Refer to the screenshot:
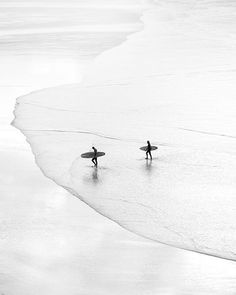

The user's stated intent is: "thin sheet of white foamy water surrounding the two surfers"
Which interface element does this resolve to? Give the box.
[14,1,236,259]
